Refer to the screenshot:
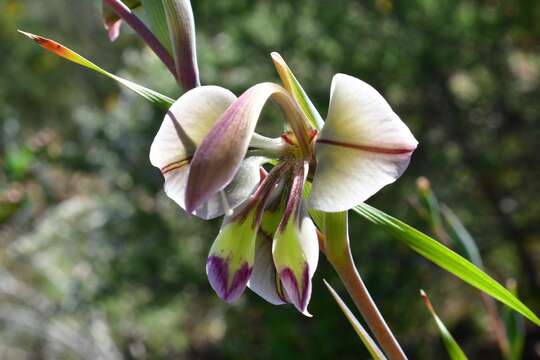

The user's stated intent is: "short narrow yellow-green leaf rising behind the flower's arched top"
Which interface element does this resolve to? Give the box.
[271,52,324,130]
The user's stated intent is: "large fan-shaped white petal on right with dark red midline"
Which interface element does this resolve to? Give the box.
[309,74,418,212]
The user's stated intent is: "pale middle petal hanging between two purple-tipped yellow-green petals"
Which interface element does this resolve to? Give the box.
[248,233,285,305]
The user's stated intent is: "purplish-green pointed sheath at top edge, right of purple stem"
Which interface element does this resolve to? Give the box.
[165,0,200,90]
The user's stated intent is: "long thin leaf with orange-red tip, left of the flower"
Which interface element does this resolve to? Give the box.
[18,30,174,109]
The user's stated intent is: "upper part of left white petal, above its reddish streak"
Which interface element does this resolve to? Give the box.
[150,86,236,169]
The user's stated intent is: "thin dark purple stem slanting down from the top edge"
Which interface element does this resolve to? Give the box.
[105,0,178,79]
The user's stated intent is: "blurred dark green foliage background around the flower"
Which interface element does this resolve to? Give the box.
[0,0,540,359]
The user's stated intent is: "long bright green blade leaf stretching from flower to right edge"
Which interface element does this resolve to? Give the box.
[353,204,540,326]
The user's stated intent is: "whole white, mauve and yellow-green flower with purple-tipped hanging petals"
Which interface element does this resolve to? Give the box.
[150,54,417,315]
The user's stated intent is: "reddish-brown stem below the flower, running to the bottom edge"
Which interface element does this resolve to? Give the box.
[329,246,407,360]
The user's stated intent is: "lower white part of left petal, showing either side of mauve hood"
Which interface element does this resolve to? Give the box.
[164,158,261,220]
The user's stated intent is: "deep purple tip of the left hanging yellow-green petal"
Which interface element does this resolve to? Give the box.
[206,256,253,302]
